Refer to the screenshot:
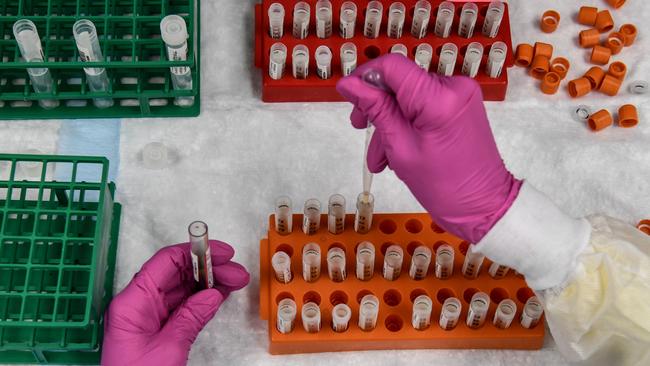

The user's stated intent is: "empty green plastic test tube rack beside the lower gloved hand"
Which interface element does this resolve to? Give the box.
[0,154,121,364]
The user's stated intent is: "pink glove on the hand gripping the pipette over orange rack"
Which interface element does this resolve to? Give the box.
[337,54,521,243]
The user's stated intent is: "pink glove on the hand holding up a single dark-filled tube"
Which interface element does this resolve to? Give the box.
[102,240,250,366]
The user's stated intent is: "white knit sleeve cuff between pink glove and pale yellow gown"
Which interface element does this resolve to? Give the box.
[474,182,591,290]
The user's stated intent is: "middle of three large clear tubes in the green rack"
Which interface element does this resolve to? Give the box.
[72,19,113,108]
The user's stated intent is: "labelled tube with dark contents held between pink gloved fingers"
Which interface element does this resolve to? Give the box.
[187,221,214,289]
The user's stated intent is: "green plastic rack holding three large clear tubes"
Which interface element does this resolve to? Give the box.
[0,0,201,120]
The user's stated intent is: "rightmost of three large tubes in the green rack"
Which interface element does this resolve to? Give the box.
[160,15,194,107]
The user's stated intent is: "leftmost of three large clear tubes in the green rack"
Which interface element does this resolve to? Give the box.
[13,19,59,109]
